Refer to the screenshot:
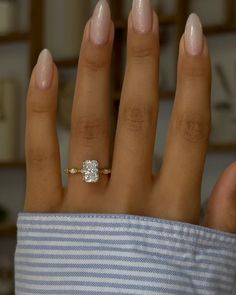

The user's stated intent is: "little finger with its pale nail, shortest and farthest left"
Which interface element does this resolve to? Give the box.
[25,49,62,212]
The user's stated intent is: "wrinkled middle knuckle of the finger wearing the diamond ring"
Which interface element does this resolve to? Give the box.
[73,117,109,145]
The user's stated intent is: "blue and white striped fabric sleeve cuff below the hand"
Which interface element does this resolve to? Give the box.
[15,213,236,295]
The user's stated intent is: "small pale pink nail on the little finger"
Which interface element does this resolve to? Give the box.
[36,49,53,90]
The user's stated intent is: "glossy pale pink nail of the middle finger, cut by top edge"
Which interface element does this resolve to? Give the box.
[132,0,153,33]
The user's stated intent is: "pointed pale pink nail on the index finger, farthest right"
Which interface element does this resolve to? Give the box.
[184,13,203,55]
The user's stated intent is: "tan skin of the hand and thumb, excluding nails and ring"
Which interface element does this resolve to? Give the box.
[25,13,236,233]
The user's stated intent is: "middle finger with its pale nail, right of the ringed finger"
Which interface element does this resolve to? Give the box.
[110,1,159,192]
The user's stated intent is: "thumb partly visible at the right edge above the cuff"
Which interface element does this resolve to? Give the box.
[203,162,236,234]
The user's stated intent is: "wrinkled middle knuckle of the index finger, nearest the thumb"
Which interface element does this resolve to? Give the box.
[174,114,210,143]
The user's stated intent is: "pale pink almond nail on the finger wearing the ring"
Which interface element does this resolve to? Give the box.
[90,0,111,45]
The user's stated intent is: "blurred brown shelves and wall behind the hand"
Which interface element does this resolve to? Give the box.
[0,0,236,295]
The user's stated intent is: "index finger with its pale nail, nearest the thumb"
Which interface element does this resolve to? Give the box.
[156,14,211,223]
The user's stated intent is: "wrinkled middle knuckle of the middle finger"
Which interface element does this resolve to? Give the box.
[123,104,155,133]
